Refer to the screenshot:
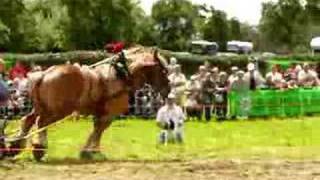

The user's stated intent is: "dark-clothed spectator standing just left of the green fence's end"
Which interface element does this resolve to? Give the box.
[214,72,228,121]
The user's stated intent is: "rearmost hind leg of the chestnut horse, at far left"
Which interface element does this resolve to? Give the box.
[6,111,38,156]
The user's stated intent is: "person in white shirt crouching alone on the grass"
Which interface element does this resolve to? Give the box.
[156,93,185,144]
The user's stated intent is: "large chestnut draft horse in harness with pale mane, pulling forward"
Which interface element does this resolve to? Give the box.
[7,47,169,160]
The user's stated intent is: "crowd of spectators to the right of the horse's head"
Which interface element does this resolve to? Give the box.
[169,58,320,121]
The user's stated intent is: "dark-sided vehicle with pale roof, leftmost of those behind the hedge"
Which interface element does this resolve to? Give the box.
[190,40,219,55]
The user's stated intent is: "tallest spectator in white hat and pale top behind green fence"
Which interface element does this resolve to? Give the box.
[244,63,265,91]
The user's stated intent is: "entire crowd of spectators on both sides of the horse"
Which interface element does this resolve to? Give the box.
[0,58,320,121]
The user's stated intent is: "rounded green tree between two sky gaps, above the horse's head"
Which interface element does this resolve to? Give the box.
[152,0,198,50]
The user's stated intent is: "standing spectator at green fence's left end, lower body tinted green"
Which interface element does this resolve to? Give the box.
[230,71,250,119]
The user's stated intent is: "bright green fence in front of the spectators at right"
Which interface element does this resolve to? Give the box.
[228,88,320,117]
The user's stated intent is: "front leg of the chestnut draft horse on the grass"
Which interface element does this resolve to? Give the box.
[80,115,112,159]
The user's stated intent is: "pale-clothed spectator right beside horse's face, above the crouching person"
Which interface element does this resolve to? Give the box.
[168,65,187,105]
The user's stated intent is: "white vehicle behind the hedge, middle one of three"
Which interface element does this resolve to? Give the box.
[227,41,253,54]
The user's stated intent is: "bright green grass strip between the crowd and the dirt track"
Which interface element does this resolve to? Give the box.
[6,117,320,161]
